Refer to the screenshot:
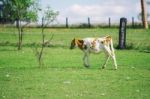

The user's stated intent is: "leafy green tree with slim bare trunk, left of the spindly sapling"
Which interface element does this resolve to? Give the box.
[4,0,38,50]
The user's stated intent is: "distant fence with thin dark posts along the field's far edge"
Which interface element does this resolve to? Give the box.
[0,17,150,28]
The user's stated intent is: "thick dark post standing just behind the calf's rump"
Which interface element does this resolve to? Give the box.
[119,18,127,49]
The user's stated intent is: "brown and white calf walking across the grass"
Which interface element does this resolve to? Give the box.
[70,36,117,69]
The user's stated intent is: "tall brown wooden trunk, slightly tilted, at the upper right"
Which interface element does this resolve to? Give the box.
[141,0,148,29]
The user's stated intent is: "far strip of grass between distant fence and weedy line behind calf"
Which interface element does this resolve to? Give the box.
[0,28,150,50]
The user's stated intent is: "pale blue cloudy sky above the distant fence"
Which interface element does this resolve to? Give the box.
[39,0,150,24]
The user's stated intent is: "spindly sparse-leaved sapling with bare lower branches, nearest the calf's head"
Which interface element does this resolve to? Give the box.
[35,7,59,67]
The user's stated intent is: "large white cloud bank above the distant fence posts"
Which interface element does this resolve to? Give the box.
[58,0,140,23]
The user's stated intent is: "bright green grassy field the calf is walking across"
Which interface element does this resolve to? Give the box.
[0,28,150,99]
